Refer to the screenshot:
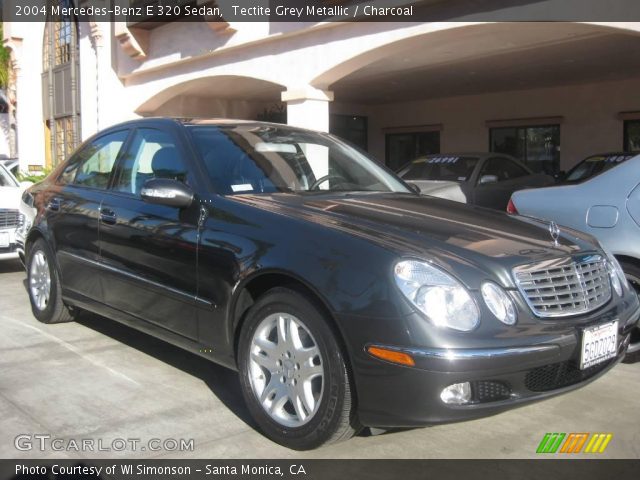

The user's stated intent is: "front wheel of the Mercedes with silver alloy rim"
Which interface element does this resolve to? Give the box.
[238,288,360,450]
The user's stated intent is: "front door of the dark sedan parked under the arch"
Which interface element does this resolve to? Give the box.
[473,156,531,210]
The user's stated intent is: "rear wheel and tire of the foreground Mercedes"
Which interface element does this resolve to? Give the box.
[27,238,74,323]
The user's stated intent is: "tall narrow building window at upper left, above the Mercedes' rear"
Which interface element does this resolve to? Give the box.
[42,0,80,166]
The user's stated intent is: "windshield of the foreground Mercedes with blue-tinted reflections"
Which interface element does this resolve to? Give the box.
[187,124,409,195]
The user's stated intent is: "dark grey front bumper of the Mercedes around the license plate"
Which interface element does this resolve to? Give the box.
[342,302,640,428]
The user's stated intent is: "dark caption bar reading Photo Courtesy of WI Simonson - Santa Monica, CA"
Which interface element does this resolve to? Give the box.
[0,458,640,480]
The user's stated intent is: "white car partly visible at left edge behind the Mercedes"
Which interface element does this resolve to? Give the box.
[0,165,30,260]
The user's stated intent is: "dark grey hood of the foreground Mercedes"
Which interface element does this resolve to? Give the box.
[236,193,596,288]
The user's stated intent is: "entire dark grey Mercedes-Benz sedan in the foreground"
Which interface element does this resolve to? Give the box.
[23,119,640,449]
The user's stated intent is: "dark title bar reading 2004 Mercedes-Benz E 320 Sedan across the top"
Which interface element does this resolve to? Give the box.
[1,0,640,22]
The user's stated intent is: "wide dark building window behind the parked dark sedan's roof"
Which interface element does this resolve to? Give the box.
[489,125,560,175]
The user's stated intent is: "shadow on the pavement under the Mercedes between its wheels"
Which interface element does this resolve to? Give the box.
[76,312,258,431]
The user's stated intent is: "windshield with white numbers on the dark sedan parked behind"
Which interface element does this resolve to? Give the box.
[399,156,479,182]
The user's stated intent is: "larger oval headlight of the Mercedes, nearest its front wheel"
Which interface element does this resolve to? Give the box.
[393,260,480,332]
